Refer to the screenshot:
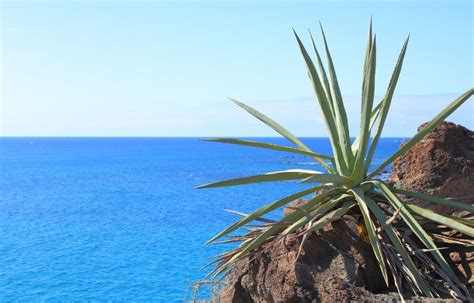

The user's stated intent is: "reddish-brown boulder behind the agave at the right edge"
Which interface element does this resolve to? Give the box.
[391,122,474,212]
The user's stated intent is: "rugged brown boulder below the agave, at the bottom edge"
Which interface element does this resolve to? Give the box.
[221,221,392,302]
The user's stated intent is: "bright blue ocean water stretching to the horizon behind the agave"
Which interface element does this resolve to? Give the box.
[0,138,404,302]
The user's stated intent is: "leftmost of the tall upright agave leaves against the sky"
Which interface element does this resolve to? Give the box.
[293,31,348,175]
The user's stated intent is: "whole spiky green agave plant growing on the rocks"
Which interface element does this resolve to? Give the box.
[198,24,474,300]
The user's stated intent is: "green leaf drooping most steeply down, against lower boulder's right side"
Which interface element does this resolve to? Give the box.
[351,188,389,286]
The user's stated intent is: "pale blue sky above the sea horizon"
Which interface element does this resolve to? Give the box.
[0,0,474,137]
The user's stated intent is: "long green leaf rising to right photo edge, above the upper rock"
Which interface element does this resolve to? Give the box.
[368,88,474,178]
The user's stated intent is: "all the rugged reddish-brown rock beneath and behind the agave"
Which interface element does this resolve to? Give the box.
[220,122,474,303]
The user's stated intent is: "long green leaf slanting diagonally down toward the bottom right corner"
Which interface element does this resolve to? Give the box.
[371,181,457,281]
